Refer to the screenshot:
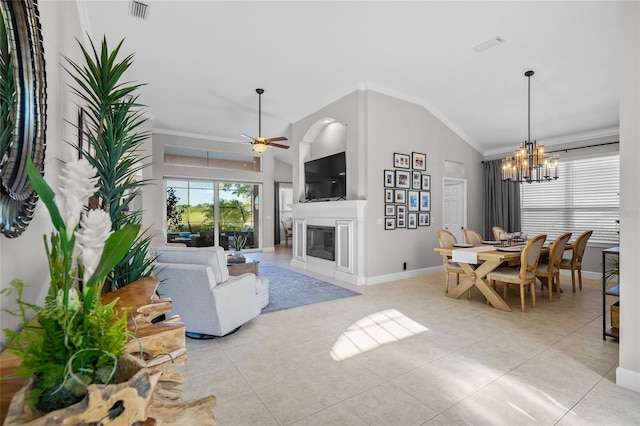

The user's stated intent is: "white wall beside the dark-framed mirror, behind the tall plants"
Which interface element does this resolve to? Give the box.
[0,1,82,338]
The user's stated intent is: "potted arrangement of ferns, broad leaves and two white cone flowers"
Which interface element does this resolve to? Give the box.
[3,159,140,414]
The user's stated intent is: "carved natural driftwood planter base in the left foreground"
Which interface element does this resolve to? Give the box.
[2,277,216,426]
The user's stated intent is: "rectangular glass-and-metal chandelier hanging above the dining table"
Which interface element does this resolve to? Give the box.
[502,71,560,183]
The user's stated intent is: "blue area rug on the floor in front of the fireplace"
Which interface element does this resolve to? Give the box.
[259,263,360,314]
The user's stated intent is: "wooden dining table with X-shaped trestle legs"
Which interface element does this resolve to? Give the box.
[434,245,528,312]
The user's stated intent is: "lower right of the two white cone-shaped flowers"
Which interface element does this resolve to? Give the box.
[76,210,111,280]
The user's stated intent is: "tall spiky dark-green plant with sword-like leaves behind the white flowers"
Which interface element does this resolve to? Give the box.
[65,38,153,288]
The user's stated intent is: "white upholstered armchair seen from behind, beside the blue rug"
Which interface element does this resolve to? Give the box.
[154,247,269,337]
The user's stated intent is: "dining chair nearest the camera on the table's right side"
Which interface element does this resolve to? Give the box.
[487,234,547,312]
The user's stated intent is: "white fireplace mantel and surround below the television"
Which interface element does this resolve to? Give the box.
[290,200,367,285]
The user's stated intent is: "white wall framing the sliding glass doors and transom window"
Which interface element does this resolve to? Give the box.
[150,133,279,249]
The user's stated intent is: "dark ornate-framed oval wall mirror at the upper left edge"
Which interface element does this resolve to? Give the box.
[0,0,47,238]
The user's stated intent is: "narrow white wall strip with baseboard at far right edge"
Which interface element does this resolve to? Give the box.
[616,2,640,392]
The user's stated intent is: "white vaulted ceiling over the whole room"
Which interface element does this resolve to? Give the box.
[79,0,620,161]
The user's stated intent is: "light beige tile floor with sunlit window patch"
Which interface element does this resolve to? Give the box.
[176,250,640,426]
